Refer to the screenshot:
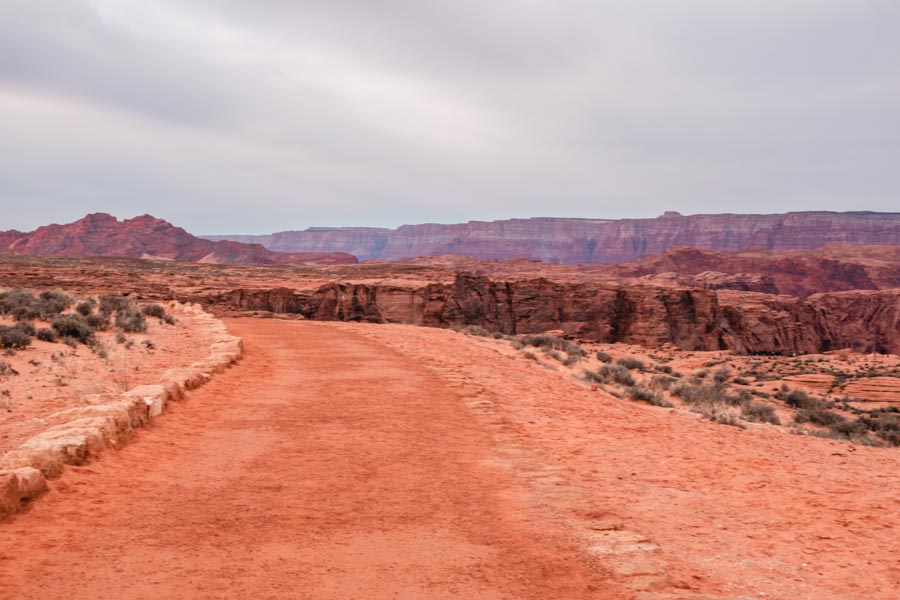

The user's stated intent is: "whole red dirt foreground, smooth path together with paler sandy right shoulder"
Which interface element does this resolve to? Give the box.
[0,319,900,600]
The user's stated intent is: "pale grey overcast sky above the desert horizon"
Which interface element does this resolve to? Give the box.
[0,0,900,233]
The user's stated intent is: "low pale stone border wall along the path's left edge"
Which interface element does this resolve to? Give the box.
[0,303,243,519]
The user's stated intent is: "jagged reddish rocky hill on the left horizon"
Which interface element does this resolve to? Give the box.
[0,213,357,265]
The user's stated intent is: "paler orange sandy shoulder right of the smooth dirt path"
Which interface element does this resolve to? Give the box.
[332,323,900,600]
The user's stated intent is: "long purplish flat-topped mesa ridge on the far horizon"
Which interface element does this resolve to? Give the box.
[203,212,900,264]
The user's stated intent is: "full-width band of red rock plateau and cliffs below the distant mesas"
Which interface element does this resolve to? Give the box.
[0,246,900,354]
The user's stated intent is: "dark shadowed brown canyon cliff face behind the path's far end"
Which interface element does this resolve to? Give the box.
[197,273,900,354]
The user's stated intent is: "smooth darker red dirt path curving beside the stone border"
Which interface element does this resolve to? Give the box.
[0,320,631,599]
